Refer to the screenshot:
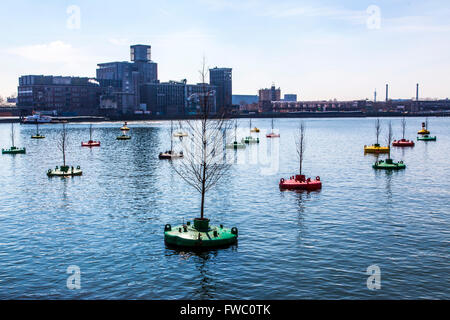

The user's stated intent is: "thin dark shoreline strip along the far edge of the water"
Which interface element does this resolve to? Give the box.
[0,111,450,124]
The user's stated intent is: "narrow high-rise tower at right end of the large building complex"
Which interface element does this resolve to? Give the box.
[209,67,233,111]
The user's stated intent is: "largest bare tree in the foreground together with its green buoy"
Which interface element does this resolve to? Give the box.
[164,59,238,248]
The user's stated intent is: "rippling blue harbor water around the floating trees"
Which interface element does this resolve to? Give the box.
[0,118,450,299]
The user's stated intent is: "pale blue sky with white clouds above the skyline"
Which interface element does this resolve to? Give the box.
[0,0,450,100]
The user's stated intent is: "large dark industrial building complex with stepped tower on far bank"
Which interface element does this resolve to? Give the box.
[17,44,232,116]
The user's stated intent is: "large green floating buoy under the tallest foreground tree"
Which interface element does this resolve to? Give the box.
[164,219,238,248]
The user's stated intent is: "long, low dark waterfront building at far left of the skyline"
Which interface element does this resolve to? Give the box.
[17,75,100,115]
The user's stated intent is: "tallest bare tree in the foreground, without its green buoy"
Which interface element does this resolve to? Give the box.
[172,58,231,219]
